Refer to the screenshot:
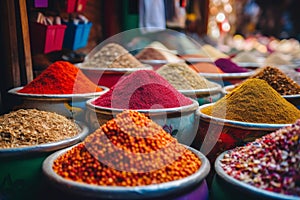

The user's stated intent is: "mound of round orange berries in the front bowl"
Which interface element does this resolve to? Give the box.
[53,110,201,186]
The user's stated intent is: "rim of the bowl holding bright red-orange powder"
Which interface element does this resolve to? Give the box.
[8,86,109,100]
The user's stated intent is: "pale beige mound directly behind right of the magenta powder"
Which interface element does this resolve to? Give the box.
[156,63,216,90]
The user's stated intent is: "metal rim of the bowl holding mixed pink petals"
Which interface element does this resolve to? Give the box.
[214,149,299,200]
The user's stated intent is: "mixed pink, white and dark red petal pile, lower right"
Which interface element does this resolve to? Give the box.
[221,120,300,196]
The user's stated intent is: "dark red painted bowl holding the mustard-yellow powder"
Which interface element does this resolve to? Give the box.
[192,103,290,163]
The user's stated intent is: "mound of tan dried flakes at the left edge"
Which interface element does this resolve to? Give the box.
[0,109,80,148]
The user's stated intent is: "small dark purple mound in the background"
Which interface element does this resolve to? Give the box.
[215,58,249,73]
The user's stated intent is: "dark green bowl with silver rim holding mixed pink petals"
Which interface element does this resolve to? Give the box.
[211,152,300,200]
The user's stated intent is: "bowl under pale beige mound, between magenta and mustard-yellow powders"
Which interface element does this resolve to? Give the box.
[178,83,222,106]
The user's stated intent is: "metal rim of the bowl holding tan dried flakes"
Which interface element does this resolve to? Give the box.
[0,121,89,158]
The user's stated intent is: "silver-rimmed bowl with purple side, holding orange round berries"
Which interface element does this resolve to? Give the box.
[43,147,210,200]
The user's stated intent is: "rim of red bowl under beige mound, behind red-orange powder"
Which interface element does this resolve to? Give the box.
[76,63,153,73]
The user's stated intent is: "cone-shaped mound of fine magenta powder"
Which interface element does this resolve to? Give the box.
[93,70,192,110]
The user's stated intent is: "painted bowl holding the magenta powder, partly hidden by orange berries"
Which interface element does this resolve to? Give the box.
[86,98,199,146]
